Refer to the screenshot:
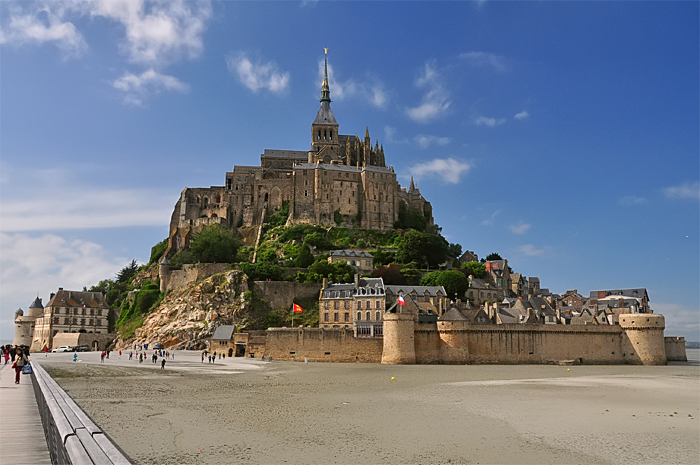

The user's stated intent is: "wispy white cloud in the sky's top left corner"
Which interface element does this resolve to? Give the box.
[0,5,87,56]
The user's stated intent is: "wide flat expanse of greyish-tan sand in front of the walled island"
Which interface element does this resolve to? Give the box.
[38,352,700,464]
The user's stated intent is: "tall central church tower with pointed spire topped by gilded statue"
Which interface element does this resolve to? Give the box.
[309,48,340,163]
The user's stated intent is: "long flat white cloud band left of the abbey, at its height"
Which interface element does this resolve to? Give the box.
[0,166,178,232]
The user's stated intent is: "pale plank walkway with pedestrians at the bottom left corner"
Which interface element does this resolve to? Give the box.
[0,363,51,465]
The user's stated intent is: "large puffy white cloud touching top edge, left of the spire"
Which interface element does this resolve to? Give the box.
[89,0,212,66]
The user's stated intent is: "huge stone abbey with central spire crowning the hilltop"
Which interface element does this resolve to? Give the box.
[166,55,433,257]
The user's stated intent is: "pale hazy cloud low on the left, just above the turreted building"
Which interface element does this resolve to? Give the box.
[0,232,128,338]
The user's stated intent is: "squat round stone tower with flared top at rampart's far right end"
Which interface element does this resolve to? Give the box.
[619,313,666,365]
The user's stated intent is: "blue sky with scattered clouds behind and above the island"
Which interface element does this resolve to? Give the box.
[0,0,700,340]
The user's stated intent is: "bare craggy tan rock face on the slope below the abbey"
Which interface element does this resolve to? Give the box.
[115,270,250,349]
